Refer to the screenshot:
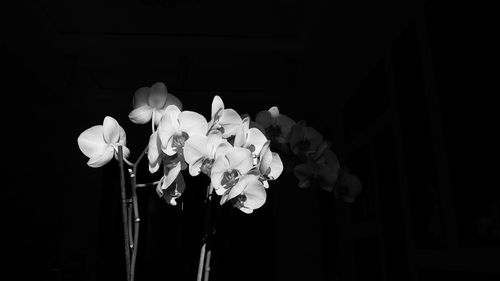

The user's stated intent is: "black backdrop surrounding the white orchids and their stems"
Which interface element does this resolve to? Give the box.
[0,0,500,280]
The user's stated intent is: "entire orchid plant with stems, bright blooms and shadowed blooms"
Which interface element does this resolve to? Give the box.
[78,82,361,280]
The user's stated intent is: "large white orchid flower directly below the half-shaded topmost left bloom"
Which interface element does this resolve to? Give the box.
[158,105,208,156]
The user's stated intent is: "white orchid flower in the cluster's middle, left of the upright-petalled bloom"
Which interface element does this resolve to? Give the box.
[184,131,232,176]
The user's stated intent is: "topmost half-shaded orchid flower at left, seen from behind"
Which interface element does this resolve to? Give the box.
[128,82,182,125]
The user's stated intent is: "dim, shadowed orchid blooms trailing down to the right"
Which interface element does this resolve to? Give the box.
[256,107,362,203]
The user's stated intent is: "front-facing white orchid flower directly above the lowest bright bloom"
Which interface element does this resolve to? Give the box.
[210,147,253,195]
